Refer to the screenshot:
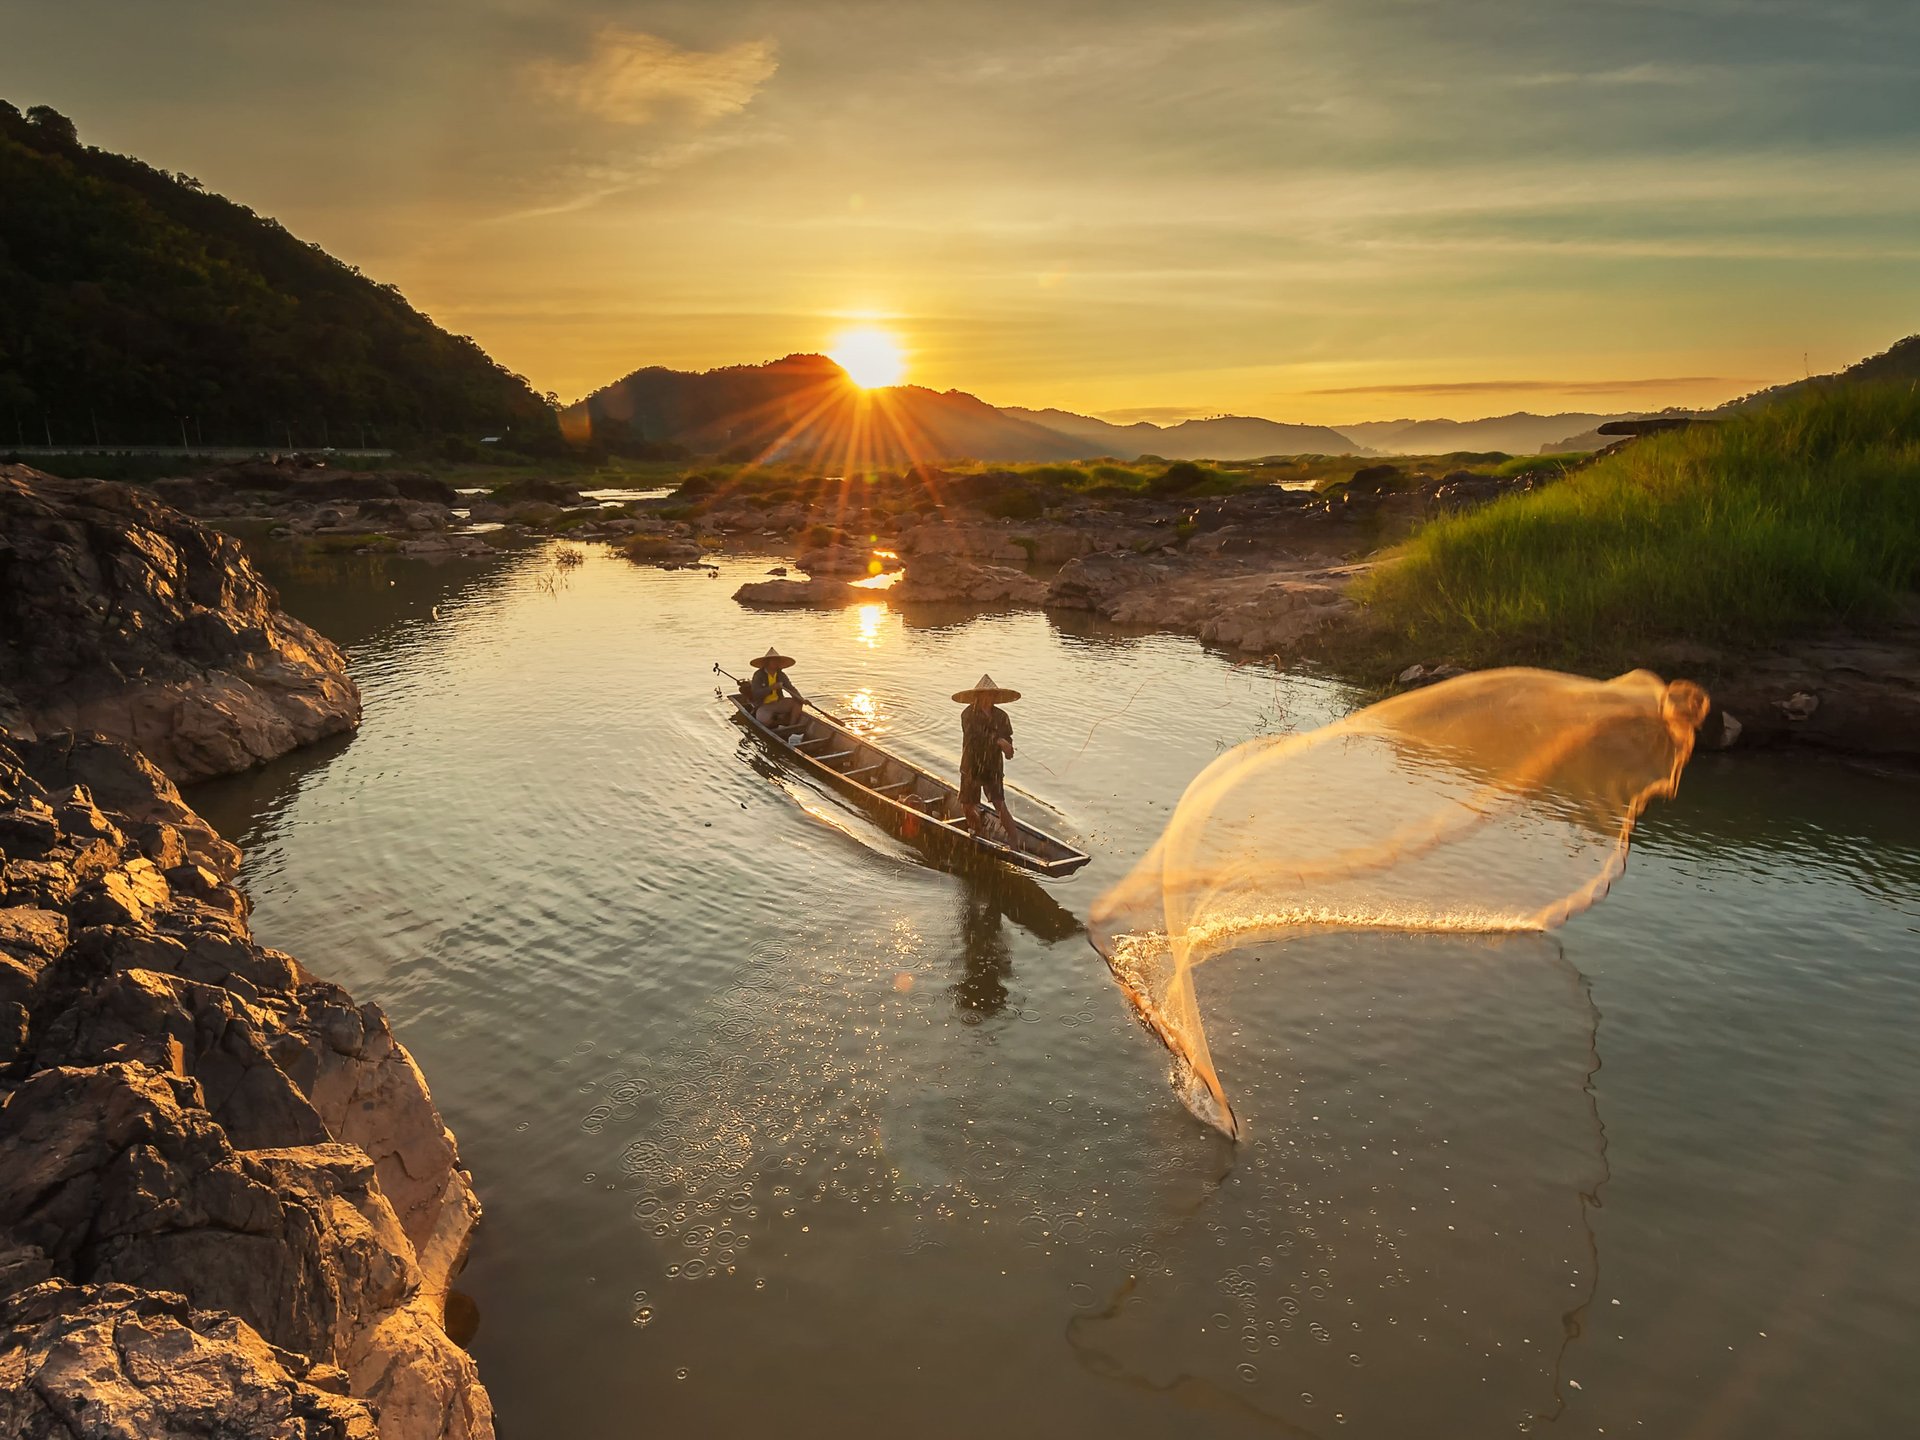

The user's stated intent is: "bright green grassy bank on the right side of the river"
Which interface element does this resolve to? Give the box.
[1361,384,1920,666]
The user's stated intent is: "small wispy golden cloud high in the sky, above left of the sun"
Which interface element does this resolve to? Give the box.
[526,25,780,125]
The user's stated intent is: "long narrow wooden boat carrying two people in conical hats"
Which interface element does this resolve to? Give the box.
[726,695,1092,876]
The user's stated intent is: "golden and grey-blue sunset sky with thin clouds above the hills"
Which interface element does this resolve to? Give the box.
[0,0,1920,422]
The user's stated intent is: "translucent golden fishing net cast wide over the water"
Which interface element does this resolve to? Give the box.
[1089,670,1707,1135]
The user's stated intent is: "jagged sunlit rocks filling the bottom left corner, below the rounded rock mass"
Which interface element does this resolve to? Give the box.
[0,739,492,1440]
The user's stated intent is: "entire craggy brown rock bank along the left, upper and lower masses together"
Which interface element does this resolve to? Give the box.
[0,467,493,1440]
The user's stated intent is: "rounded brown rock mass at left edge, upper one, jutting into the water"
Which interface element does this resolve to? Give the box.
[0,465,361,783]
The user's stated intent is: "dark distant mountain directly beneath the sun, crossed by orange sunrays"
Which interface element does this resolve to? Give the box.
[561,355,1100,468]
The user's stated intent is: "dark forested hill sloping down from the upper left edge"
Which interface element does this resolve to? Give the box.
[0,100,557,447]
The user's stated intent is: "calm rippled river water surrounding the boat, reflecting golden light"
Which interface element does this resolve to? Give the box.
[192,549,1920,1438]
